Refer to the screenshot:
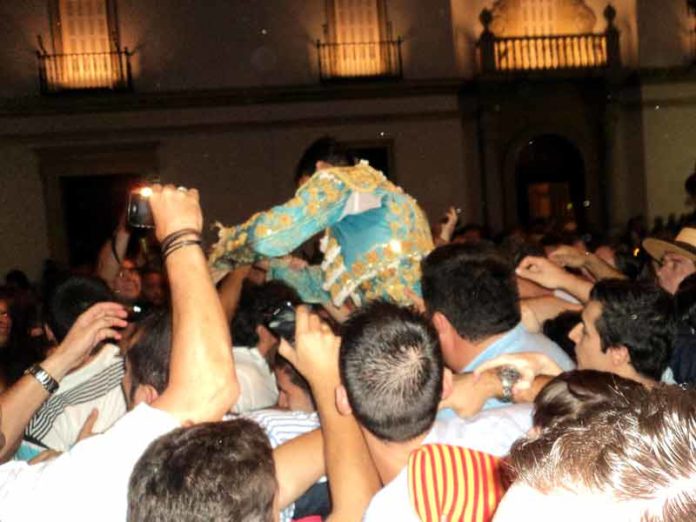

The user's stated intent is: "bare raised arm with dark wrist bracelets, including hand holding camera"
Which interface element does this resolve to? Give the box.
[150,185,239,424]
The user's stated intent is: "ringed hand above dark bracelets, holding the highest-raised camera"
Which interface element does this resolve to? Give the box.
[150,185,203,242]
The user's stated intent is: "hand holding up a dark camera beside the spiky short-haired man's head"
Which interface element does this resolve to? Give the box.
[279,306,341,387]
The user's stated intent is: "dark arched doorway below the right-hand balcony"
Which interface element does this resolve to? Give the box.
[515,134,588,227]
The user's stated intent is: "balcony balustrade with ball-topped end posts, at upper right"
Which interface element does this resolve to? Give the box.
[478,6,621,73]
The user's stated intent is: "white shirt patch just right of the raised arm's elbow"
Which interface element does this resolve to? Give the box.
[232,347,278,413]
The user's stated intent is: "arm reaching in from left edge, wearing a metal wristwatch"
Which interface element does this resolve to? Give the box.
[0,303,127,462]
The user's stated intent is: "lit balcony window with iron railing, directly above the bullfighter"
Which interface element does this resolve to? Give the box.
[317,0,401,80]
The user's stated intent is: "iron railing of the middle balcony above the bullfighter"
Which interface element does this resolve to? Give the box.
[317,38,402,81]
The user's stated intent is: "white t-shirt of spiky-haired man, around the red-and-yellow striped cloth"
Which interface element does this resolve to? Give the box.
[363,404,532,522]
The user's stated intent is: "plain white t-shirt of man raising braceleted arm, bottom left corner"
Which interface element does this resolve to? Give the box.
[0,404,179,522]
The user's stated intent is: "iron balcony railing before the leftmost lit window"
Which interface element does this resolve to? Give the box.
[36,48,133,94]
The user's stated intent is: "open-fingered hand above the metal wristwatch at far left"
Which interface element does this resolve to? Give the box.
[52,303,128,372]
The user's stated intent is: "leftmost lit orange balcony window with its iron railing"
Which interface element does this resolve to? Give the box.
[38,0,131,93]
